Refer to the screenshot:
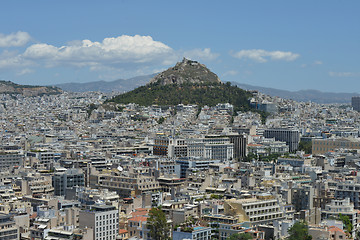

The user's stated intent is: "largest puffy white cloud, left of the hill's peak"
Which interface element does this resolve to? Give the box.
[23,35,173,67]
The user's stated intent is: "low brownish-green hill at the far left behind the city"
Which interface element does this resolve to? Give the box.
[0,80,62,97]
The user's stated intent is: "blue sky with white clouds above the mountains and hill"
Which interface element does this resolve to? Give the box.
[0,0,360,93]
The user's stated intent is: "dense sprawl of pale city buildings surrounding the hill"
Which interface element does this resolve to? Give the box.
[0,64,360,240]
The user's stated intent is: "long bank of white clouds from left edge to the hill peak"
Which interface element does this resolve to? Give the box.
[0,35,219,79]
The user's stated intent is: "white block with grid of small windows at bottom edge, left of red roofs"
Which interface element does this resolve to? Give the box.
[79,205,119,240]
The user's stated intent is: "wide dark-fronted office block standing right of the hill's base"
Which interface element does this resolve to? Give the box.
[264,128,300,152]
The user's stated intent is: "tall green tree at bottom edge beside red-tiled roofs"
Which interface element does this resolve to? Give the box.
[147,207,170,240]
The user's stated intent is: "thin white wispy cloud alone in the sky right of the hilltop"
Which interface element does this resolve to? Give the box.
[231,49,300,63]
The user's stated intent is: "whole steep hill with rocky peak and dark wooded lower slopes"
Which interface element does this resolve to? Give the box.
[108,59,251,111]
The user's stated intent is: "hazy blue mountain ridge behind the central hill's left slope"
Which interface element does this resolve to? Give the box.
[55,74,156,92]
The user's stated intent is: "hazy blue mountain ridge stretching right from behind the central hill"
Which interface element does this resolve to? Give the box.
[232,82,360,104]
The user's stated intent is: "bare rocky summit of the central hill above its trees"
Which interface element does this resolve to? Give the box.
[150,58,221,85]
